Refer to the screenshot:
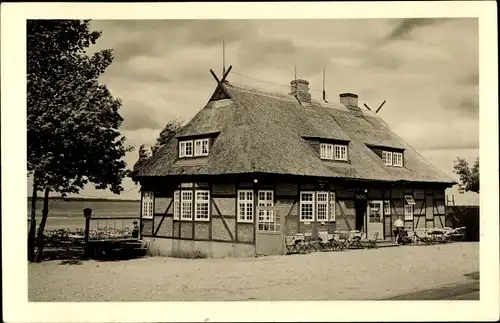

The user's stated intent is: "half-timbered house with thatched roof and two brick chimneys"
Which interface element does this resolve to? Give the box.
[137,72,454,255]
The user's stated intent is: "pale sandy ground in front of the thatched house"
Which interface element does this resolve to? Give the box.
[28,242,479,301]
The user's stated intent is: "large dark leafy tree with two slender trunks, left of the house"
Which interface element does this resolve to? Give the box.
[27,20,132,261]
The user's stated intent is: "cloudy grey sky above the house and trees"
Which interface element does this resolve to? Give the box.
[28,18,479,204]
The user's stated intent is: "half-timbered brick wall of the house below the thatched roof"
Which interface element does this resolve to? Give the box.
[141,178,446,244]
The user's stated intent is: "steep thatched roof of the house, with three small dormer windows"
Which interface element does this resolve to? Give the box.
[137,84,453,184]
